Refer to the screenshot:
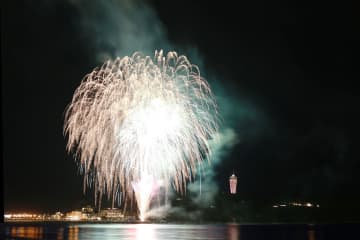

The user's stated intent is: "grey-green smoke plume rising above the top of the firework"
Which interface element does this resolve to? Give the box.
[69,0,172,62]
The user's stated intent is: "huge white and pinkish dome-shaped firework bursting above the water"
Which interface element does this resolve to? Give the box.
[64,51,217,219]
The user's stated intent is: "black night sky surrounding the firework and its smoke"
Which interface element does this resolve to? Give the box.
[1,0,360,214]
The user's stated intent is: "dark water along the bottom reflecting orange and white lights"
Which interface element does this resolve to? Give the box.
[0,223,360,240]
